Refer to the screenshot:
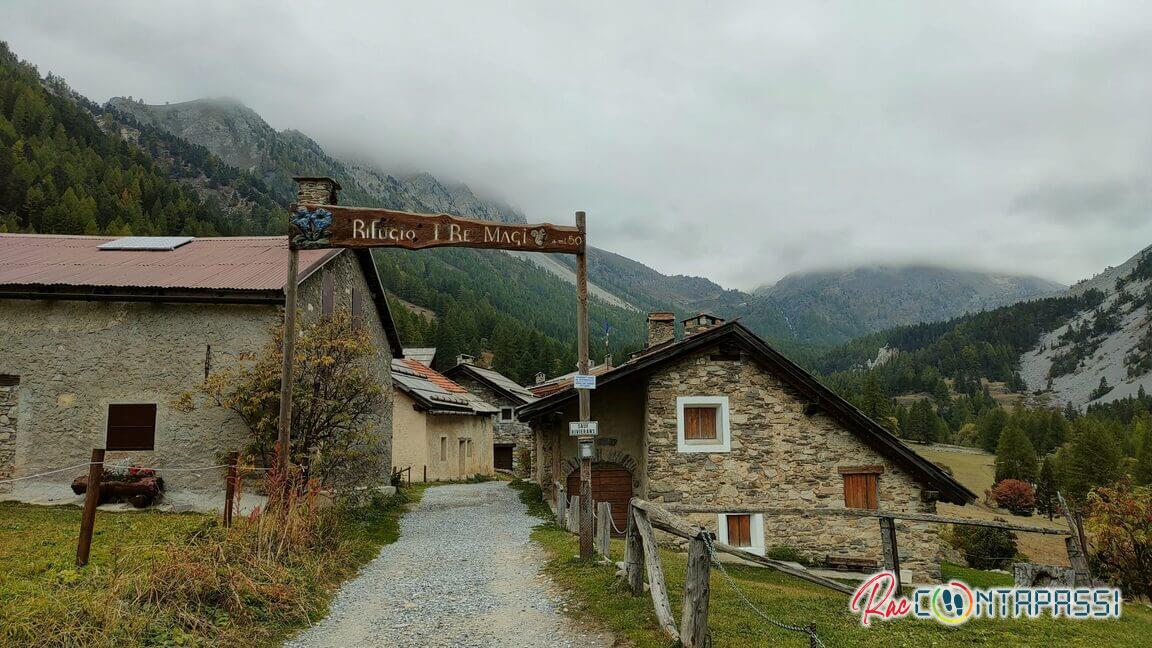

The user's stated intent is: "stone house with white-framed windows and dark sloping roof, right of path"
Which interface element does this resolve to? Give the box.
[518,312,976,578]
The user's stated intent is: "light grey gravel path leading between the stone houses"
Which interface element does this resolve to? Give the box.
[286,482,613,648]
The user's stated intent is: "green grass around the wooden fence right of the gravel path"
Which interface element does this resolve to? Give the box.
[532,525,1152,648]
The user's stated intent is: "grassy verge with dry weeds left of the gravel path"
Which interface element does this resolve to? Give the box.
[0,484,425,648]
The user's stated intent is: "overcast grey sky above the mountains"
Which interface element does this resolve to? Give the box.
[0,0,1152,288]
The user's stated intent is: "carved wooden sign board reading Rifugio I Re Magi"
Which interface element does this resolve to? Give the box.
[288,204,584,254]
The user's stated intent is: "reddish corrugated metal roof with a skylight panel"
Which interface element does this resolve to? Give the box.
[0,234,341,291]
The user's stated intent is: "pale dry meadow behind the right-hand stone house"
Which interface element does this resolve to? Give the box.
[912,445,1068,566]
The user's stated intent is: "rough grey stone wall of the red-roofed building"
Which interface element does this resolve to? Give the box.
[0,246,392,506]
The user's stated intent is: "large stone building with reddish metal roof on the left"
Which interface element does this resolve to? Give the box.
[0,234,401,506]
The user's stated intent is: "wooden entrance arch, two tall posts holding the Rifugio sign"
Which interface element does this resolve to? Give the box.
[278,178,596,558]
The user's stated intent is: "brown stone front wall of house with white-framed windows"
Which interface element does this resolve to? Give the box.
[646,351,940,580]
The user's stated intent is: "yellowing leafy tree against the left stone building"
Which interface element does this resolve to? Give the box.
[177,310,388,491]
